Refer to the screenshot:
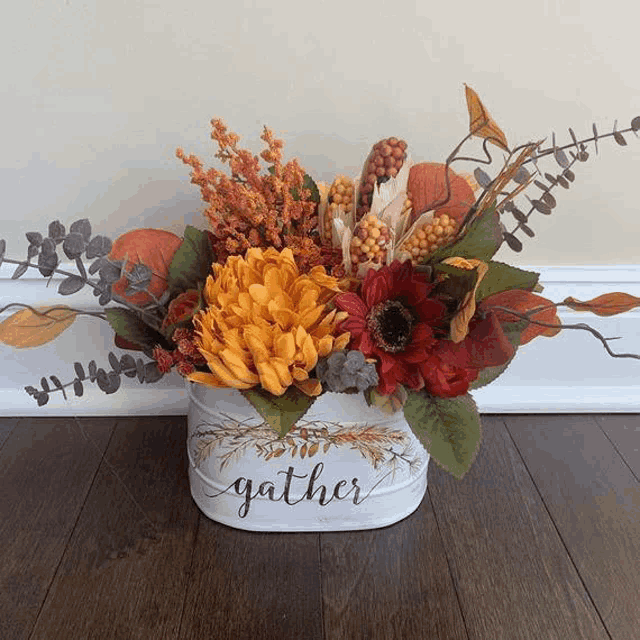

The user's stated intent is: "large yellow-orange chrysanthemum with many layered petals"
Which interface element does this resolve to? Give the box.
[189,248,350,396]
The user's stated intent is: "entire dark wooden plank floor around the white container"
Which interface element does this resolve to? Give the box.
[0,415,640,640]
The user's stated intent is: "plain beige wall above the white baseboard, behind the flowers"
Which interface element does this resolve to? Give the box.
[0,0,640,265]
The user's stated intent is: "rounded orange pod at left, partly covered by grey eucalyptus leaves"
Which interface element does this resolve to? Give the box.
[109,229,182,306]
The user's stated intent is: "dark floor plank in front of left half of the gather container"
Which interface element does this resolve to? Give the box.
[179,515,323,640]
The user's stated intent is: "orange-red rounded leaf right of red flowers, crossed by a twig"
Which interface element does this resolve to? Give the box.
[480,289,561,345]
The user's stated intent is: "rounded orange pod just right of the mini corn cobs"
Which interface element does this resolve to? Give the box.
[407,162,476,227]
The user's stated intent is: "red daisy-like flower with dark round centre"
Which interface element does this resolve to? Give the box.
[335,261,447,395]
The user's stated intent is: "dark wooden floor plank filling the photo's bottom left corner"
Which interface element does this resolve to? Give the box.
[0,418,115,640]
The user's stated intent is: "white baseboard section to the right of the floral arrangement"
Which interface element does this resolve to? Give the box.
[472,265,640,413]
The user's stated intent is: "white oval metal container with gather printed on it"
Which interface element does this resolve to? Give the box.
[187,382,429,532]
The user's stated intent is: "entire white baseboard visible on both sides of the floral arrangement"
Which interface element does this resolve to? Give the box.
[0,264,640,416]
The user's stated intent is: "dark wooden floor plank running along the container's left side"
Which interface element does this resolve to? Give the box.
[32,417,198,640]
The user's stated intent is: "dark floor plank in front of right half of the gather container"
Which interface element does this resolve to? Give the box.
[321,490,467,640]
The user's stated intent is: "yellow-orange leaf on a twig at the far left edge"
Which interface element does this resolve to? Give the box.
[0,306,78,349]
